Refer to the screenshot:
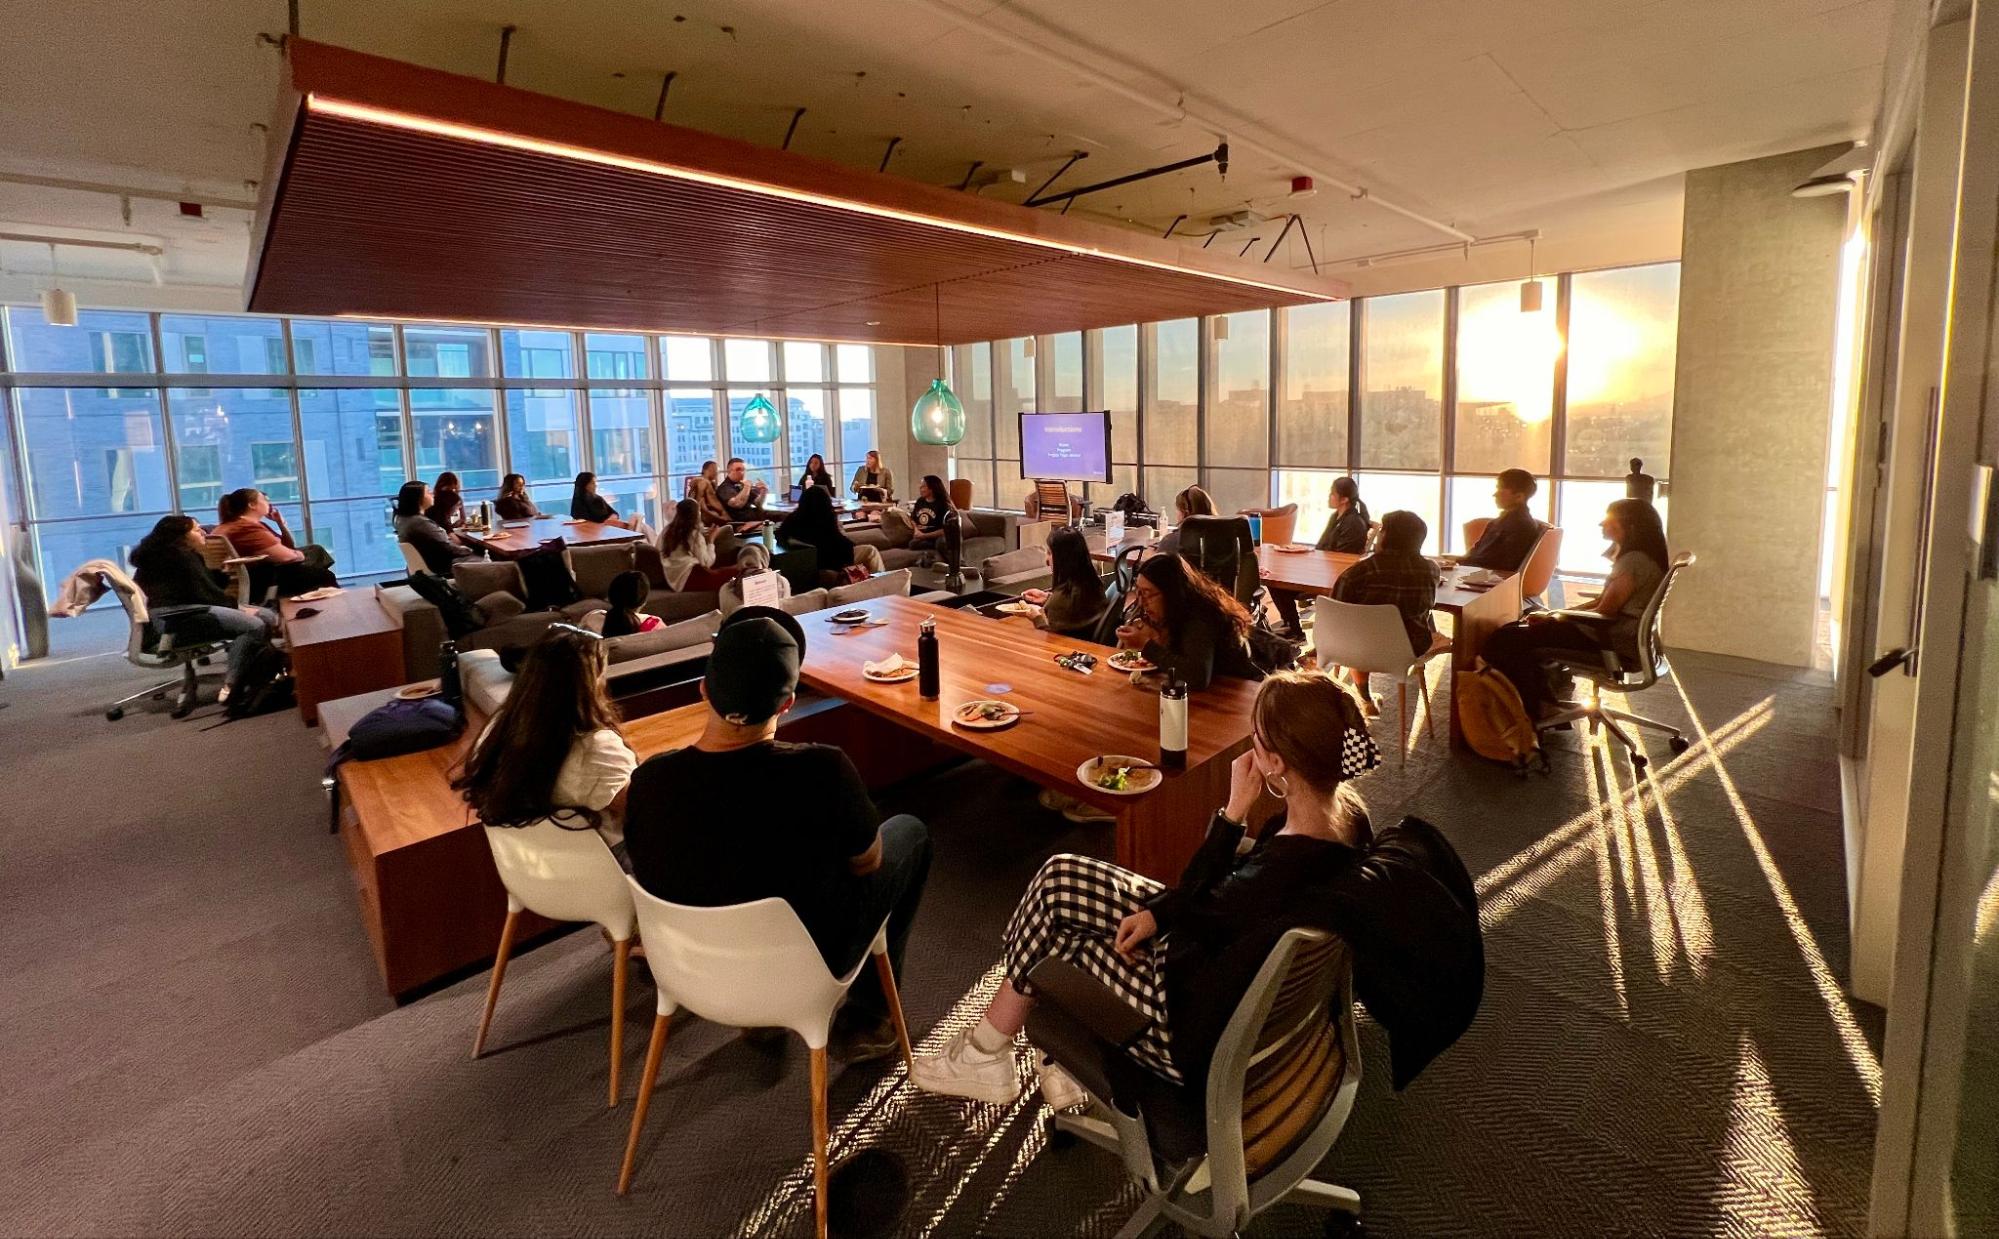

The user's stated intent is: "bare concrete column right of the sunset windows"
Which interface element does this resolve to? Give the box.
[1665,146,1847,667]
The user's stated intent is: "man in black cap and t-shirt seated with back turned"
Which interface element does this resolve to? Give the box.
[626,608,930,1061]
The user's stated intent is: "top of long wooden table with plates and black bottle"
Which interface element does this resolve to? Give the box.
[800,598,1257,809]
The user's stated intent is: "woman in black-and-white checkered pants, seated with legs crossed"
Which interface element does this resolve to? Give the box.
[910,671,1381,1109]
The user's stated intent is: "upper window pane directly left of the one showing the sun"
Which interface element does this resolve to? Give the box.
[1359,290,1443,470]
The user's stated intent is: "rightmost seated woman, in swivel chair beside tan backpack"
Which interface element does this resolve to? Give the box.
[1479,500,1673,719]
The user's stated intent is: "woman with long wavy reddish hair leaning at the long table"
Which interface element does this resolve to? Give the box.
[1117,556,1263,691]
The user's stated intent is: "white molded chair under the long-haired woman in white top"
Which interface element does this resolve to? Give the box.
[472,819,636,1105]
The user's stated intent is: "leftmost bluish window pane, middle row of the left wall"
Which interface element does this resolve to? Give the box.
[14,388,174,520]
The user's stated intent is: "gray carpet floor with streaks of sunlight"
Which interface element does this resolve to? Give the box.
[0,620,1881,1235]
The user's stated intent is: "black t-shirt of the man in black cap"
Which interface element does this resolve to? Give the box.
[626,741,882,965]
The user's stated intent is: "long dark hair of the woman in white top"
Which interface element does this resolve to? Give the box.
[452,623,622,829]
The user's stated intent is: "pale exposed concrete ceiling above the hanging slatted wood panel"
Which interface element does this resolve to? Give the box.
[0,0,1897,306]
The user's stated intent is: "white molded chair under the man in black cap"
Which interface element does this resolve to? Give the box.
[618,881,910,1239]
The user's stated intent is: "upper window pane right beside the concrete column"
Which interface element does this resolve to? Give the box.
[1563,262,1679,477]
